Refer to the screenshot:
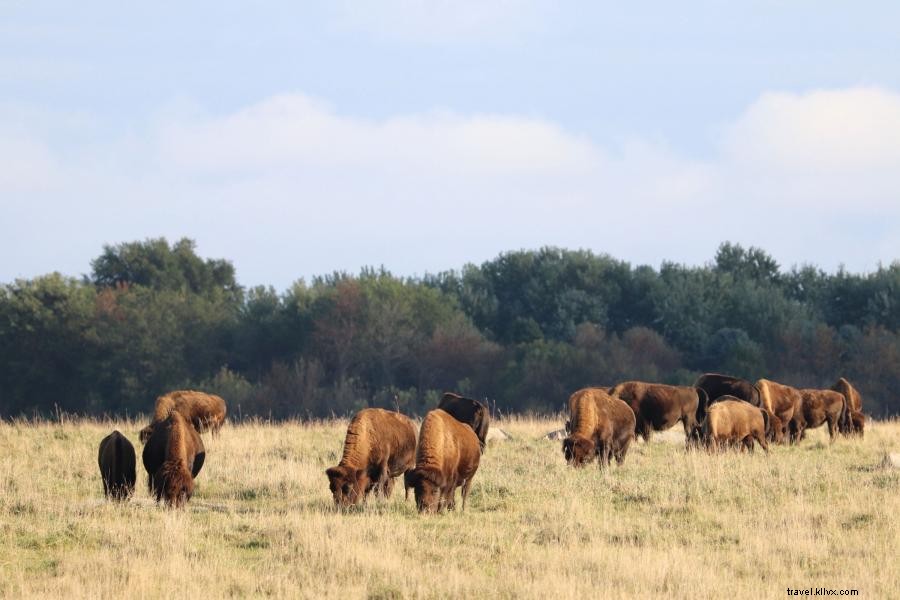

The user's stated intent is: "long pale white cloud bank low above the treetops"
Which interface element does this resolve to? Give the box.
[0,89,900,287]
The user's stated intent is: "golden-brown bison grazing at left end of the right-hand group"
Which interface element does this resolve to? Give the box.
[562,388,635,468]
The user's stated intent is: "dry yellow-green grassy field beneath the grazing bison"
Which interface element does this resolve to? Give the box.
[0,419,900,599]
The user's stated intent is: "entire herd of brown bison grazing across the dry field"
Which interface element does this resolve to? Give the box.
[98,373,865,512]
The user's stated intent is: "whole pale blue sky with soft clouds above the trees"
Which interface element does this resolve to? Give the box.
[0,0,900,289]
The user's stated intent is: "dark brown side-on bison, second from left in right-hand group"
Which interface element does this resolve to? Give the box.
[609,381,707,443]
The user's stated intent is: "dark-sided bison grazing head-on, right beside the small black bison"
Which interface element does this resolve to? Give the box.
[142,410,206,507]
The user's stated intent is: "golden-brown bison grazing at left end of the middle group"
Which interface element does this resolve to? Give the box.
[325,408,416,507]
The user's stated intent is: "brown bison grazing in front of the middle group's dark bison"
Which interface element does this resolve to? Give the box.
[404,408,481,512]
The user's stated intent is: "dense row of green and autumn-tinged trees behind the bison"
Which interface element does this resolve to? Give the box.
[0,239,900,418]
